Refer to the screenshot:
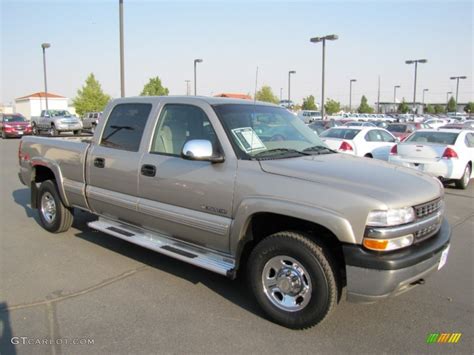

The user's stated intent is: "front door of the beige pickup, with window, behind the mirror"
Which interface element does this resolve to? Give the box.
[139,100,237,252]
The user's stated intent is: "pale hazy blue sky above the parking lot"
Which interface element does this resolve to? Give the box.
[0,0,474,105]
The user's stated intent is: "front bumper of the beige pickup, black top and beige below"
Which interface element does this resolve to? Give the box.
[343,219,451,303]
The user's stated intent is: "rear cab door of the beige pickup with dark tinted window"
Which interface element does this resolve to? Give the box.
[86,102,153,224]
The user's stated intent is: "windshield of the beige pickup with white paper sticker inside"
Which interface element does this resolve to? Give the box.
[214,104,331,159]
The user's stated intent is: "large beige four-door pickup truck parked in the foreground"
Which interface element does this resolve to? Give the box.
[19,97,451,329]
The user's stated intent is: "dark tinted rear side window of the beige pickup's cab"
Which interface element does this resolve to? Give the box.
[100,104,151,152]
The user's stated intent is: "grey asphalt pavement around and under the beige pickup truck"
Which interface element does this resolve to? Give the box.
[0,139,474,354]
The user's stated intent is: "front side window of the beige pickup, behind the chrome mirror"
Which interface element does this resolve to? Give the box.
[150,105,217,156]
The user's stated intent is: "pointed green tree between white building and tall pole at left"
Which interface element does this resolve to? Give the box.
[72,73,110,116]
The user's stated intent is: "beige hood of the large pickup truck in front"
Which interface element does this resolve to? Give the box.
[260,154,443,207]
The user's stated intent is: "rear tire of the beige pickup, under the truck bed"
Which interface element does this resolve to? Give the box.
[37,180,74,233]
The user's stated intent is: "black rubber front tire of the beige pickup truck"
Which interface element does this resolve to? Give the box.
[248,231,340,329]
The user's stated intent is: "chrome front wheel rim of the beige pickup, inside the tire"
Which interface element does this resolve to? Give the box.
[262,255,312,312]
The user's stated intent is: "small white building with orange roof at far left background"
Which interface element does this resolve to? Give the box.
[15,92,69,120]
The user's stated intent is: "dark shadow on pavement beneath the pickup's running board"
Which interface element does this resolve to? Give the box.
[74,211,264,318]
